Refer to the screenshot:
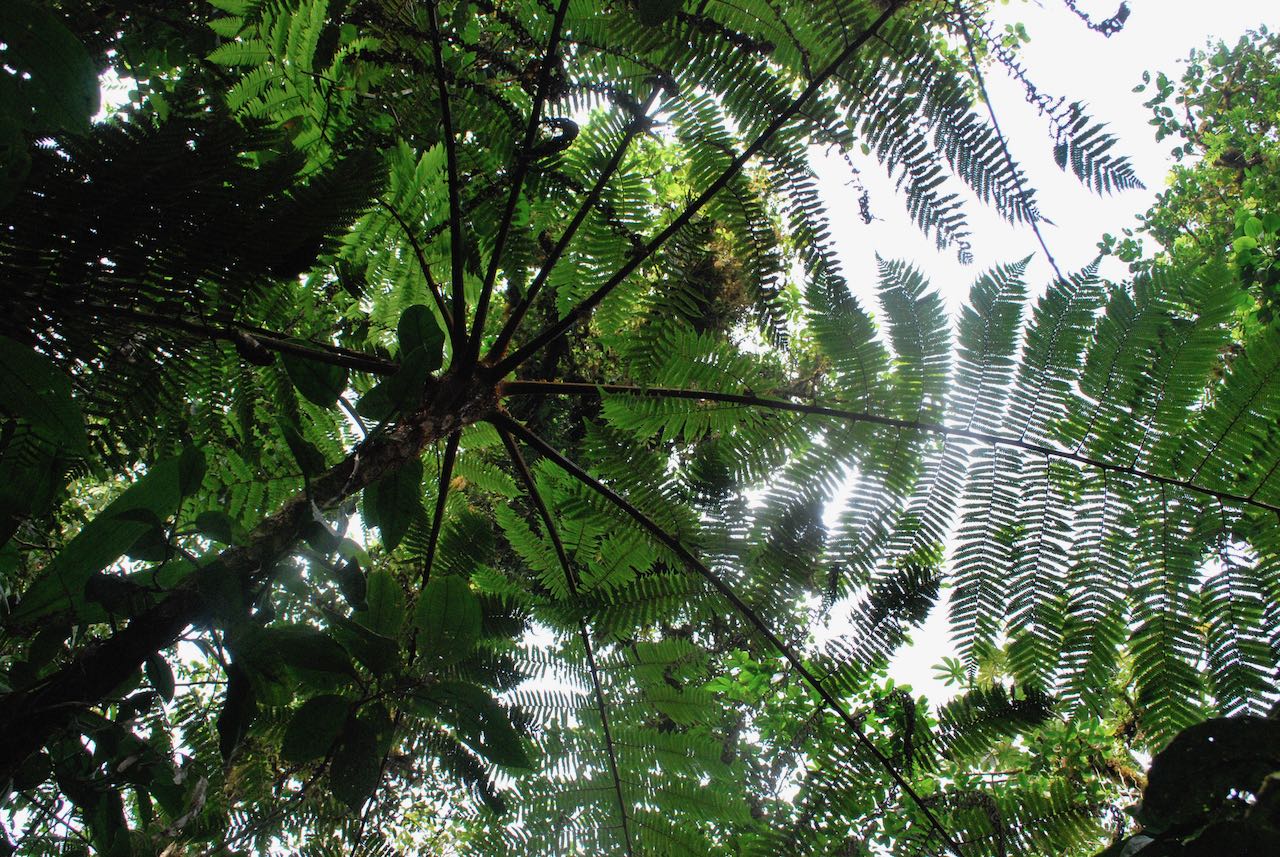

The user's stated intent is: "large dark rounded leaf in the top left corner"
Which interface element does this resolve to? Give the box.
[0,0,100,133]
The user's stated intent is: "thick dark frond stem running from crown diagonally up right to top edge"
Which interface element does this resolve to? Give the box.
[490,0,904,377]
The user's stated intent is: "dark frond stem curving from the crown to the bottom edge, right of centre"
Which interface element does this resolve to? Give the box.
[490,412,963,857]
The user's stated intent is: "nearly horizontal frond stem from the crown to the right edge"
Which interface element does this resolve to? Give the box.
[499,381,1280,515]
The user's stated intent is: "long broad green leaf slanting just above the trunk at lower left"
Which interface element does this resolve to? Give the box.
[10,457,197,624]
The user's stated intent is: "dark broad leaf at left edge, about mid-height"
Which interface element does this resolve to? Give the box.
[0,336,88,455]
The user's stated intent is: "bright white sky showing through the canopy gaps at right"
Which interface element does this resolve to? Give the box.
[818,0,1280,702]
